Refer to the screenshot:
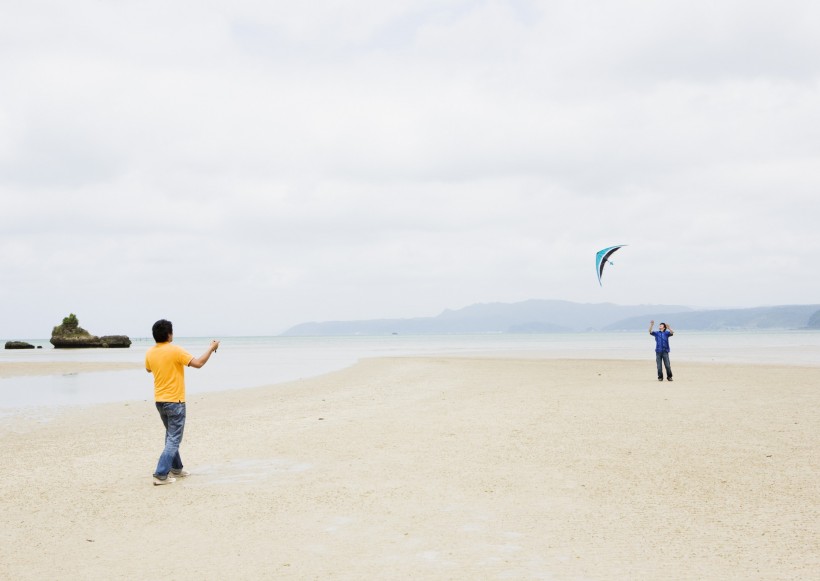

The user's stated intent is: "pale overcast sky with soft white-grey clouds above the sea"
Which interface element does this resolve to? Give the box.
[0,0,820,339]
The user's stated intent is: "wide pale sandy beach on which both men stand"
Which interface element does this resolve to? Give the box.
[0,357,820,580]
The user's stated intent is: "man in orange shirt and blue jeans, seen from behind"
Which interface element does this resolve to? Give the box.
[145,319,219,486]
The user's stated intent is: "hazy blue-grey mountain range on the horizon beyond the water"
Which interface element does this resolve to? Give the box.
[282,300,820,337]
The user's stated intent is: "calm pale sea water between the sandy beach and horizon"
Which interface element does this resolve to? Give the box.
[0,331,820,415]
